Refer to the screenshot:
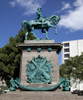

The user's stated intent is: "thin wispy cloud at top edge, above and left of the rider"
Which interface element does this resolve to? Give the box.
[10,0,46,15]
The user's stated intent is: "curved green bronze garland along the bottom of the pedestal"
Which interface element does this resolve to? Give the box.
[9,78,69,91]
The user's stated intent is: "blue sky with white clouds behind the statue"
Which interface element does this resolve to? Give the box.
[0,0,83,65]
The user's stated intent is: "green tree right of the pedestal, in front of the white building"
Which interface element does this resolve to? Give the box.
[60,53,83,80]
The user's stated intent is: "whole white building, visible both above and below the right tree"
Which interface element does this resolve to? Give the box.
[62,39,83,93]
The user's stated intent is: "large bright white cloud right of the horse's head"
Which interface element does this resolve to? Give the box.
[59,0,83,31]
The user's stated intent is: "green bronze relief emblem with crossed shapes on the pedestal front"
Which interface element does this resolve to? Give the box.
[26,55,53,83]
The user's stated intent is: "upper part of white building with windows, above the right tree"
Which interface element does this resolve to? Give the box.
[62,39,83,63]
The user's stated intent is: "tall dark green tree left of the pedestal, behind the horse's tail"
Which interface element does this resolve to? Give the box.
[0,30,36,84]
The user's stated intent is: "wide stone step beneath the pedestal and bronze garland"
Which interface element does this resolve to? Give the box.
[0,91,83,100]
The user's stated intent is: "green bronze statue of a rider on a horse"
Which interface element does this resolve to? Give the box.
[22,8,60,40]
